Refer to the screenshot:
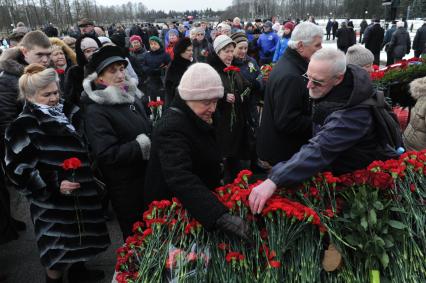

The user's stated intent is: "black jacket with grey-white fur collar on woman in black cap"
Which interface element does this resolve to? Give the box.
[82,73,150,187]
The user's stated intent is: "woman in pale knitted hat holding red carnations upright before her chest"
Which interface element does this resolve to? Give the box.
[209,35,250,183]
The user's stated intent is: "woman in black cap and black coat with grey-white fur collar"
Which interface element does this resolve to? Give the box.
[81,46,151,239]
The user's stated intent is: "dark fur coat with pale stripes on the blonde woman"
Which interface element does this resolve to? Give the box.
[5,102,109,270]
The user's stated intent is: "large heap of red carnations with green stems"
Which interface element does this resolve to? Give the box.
[116,151,426,282]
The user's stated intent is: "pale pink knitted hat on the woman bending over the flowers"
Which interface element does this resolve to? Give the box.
[178,63,224,100]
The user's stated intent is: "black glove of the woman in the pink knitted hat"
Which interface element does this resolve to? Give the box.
[216,213,250,242]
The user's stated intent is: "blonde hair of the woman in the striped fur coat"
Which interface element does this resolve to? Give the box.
[18,63,59,100]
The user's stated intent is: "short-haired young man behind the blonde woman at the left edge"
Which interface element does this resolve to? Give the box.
[0,31,51,242]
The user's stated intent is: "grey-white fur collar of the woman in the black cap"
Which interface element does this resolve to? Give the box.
[83,73,143,105]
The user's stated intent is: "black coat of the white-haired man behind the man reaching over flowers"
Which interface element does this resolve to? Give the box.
[257,48,312,165]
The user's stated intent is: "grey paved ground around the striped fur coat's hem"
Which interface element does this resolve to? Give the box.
[0,192,122,283]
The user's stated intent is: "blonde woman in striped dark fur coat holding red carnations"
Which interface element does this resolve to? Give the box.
[5,64,110,282]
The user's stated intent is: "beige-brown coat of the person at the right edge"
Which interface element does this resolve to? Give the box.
[404,77,426,150]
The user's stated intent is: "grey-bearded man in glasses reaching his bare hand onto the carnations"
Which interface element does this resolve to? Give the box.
[249,48,397,213]
